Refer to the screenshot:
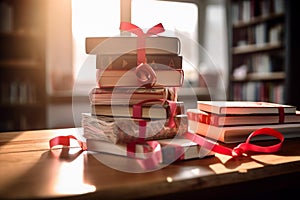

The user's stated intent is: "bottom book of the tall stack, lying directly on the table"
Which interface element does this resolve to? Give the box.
[86,138,214,163]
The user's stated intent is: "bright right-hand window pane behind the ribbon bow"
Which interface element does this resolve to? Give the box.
[131,0,198,86]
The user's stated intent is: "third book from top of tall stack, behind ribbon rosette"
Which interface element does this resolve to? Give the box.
[96,69,184,88]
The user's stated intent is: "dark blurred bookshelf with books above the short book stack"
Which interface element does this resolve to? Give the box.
[227,0,290,103]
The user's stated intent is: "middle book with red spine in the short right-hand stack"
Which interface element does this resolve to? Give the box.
[187,109,300,126]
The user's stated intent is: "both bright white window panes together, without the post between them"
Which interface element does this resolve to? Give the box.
[72,0,198,83]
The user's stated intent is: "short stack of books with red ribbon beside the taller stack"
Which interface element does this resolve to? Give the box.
[187,101,300,143]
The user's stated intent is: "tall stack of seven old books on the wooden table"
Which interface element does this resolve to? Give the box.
[82,36,212,162]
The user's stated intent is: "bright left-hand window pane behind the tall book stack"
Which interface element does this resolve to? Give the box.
[72,0,120,84]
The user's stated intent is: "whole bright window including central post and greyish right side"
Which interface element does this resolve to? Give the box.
[72,0,227,98]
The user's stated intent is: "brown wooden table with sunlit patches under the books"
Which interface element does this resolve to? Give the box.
[0,128,300,199]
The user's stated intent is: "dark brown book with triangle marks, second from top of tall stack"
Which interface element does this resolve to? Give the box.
[96,54,182,70]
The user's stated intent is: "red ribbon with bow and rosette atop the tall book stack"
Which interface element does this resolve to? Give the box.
[120,22,165,87]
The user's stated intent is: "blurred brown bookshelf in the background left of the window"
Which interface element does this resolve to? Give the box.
[0,0,47,131]
